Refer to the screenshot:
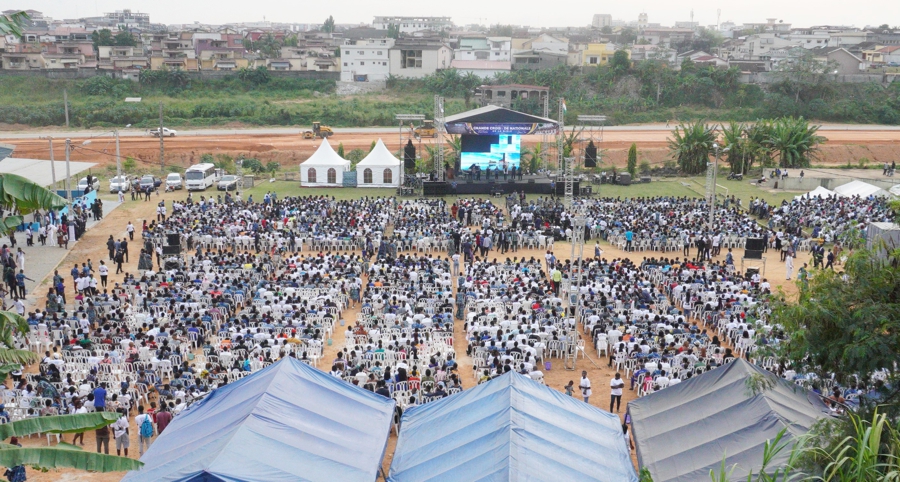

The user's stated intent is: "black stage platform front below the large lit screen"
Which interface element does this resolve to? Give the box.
[424,174,581,196]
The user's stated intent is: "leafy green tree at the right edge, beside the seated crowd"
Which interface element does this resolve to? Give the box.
[771,249,900,416]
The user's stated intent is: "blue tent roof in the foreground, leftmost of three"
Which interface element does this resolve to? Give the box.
[123,358,394,482]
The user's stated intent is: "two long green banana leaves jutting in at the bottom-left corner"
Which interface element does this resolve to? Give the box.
[0,412,144,472]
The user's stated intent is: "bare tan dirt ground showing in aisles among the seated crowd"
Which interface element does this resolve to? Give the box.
[8,186,810,482]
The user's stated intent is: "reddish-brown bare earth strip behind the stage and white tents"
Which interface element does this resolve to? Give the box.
[0,129,900,174]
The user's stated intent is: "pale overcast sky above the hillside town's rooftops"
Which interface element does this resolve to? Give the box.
[14,0,900,27]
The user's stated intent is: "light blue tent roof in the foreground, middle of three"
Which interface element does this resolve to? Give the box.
[388,372,638,482]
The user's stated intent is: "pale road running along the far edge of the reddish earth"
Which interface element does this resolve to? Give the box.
[0,124,900,140]
